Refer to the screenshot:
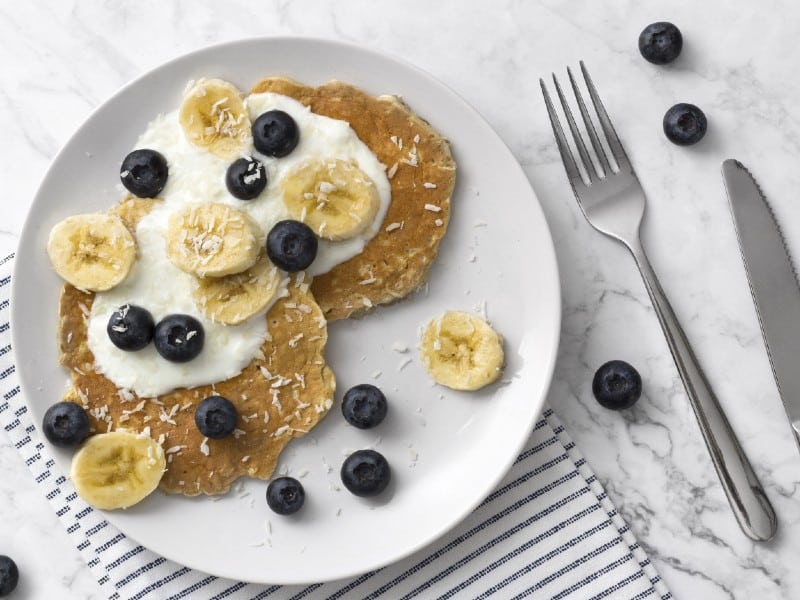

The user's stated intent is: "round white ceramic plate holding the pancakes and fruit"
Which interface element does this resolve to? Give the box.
[12,38,560,584]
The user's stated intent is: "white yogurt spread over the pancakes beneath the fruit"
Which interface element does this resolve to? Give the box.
[88,93,391,397]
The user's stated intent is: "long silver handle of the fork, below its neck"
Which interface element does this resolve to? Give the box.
[628,237,778,541]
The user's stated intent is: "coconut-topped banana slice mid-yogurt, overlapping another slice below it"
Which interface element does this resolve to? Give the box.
[167,203,260,277]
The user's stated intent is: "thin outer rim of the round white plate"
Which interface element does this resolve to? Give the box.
[10,35,563,585]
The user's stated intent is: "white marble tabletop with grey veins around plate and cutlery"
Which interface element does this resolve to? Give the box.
[0,0,800,600]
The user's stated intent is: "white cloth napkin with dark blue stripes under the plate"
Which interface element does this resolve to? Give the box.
[0,255,672,600]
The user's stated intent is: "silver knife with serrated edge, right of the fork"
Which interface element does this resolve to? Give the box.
[722,159,800,449]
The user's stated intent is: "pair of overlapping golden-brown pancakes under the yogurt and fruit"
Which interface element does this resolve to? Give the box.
[58,77,456,496]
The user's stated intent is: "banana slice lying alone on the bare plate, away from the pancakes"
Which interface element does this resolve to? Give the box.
[421,311,504,390]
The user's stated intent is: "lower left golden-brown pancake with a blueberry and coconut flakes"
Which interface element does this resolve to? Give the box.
[58,198,335,496]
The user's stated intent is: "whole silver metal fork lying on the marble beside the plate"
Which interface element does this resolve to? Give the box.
[539,61,777,541]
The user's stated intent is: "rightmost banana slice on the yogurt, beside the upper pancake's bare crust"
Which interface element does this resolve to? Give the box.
[282,159,380,240]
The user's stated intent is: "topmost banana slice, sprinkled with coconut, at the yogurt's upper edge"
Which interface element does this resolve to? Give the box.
[178,79,251,159]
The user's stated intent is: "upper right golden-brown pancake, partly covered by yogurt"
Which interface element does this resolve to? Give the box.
[252,77,456,321]
